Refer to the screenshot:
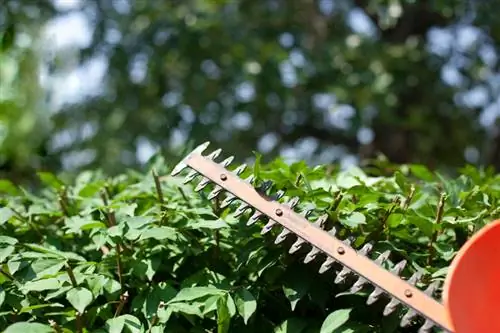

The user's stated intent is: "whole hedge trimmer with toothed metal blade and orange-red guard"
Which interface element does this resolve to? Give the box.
[171,142,500,333]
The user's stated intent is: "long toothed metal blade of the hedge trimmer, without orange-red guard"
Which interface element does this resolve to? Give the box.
[171,142,498,333]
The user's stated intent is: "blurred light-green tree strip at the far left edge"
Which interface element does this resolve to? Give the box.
[0,1,55,179]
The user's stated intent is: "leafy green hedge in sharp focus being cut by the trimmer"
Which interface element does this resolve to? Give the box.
[0,158,500,333]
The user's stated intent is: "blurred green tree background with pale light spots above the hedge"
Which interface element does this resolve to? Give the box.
[0,0,500,181]
